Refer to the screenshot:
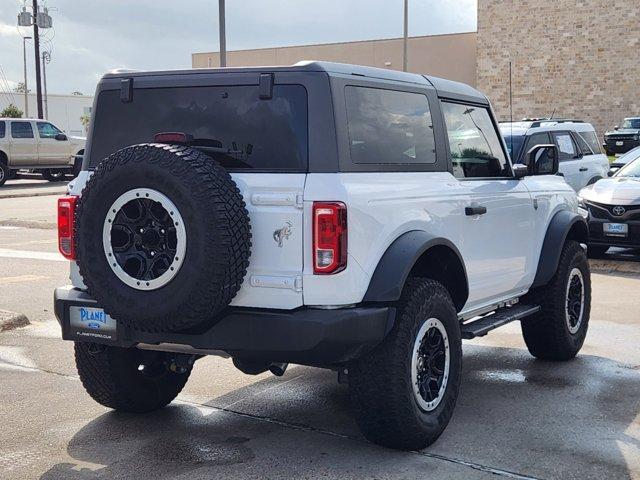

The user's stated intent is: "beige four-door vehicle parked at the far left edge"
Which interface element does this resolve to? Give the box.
[0,118,85,186]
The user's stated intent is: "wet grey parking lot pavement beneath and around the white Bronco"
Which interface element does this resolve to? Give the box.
[0,180,640,480]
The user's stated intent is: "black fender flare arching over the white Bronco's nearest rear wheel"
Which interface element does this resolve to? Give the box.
[363,230,468,302]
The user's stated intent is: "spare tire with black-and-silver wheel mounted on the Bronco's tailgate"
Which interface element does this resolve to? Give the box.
[76,144,251,332]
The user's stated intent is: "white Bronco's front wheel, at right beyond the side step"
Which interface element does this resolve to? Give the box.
[521,240,591,361]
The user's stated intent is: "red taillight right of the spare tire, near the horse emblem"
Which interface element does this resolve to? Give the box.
[313,202,347,275]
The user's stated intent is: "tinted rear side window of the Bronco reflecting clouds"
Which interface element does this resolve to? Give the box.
[345,86,436,165]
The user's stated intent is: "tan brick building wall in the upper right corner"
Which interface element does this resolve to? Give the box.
[477,0,640,136]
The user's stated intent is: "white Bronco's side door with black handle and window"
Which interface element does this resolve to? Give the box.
[442,102,534,311]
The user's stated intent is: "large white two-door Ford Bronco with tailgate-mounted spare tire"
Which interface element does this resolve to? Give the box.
[55,62,591,449]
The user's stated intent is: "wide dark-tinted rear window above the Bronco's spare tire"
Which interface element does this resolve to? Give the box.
[89,85,308,172]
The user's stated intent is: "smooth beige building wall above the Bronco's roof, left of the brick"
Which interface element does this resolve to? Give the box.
[192,32,476,85]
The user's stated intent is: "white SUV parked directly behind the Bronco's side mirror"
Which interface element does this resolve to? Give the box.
[500,119,609,192]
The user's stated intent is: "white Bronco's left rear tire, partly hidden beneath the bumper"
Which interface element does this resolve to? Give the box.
[75,342,192,413]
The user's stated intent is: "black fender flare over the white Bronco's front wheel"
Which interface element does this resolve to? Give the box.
[531,210,589,288]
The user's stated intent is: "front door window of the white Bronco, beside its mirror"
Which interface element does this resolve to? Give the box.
[442,102,511,178]
